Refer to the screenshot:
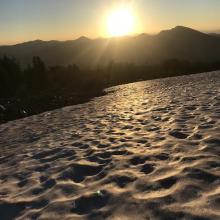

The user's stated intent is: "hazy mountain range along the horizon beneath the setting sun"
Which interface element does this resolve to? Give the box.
[0,26,220,68]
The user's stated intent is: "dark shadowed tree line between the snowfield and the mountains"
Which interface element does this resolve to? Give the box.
[0,56,220,122]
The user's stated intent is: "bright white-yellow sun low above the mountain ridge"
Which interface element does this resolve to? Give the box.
[107,7,135,37]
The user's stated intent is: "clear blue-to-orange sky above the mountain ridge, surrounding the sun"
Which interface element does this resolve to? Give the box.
[0,0,220,45]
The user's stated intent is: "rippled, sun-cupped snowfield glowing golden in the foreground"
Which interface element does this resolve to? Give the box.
[0,72,220,220]
